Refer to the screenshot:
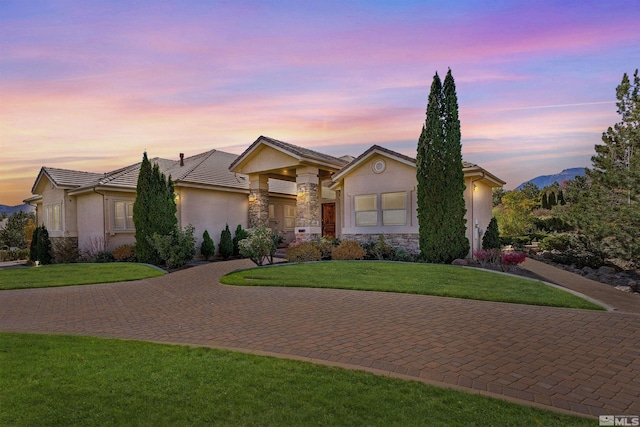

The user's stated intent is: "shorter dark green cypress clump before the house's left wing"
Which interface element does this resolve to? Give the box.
[133,152,178,264]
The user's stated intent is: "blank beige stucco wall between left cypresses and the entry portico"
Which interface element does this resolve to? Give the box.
[176,187,249,253]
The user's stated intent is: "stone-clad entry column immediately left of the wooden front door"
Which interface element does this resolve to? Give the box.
[296,167,322,241]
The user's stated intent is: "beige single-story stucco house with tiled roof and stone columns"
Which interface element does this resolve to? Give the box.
[25,136,505,258]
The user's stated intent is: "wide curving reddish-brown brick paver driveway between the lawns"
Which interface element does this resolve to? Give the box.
[0,260,640,415]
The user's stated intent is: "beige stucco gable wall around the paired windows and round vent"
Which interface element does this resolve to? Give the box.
[339,156,418,236]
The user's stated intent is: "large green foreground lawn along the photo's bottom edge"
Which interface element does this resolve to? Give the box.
[0,334,594,426]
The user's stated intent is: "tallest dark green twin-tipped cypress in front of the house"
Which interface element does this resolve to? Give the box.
[416,70,469,263]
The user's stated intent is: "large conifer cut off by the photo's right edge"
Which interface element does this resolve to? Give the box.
[571,70,640,264]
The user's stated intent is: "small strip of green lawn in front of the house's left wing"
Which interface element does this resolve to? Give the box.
[0,262,164,289]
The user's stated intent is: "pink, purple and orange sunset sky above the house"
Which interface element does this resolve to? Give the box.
[0,0,640,205]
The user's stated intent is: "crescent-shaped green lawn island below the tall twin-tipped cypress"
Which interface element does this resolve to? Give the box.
[220,261,604,310]
